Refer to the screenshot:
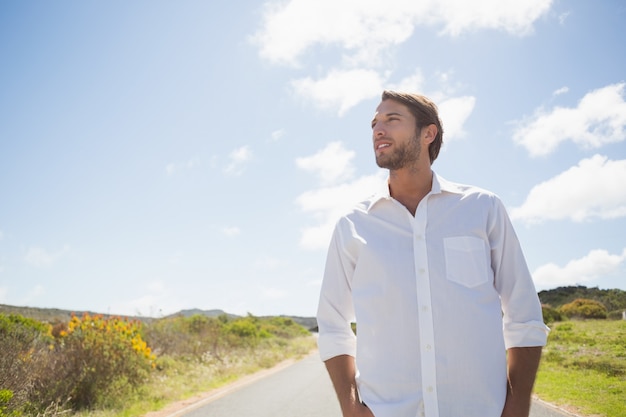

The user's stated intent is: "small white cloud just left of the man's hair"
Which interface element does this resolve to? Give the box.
[291,69,384,116]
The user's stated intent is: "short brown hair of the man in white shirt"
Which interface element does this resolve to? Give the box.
[382,90,443,164]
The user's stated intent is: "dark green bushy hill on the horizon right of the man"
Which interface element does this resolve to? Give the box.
[539,285,626,311]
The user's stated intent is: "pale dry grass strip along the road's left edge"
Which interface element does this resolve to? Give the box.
[71,336,316,417]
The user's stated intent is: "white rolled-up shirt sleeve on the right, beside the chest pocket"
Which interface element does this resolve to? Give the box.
[489,198,550,349]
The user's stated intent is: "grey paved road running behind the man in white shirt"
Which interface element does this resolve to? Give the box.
[168,354,572,417]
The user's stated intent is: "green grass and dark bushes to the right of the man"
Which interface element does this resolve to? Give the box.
[535,287,626,417]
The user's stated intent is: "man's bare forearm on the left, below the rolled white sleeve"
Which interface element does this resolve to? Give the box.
[324,355,372,417]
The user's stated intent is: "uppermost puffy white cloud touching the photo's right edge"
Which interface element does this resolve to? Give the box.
[513,83,626,156]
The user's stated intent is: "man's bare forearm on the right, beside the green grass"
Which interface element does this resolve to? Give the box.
[502,346,541,417]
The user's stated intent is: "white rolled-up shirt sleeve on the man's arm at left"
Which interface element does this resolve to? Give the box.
[317,219,356,361]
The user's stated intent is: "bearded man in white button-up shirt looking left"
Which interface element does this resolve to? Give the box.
[317,91,548,417]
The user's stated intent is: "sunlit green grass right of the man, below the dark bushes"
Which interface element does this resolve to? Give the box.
[535,320,626,417]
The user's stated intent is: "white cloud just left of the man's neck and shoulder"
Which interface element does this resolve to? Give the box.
[296,170,387,250]
